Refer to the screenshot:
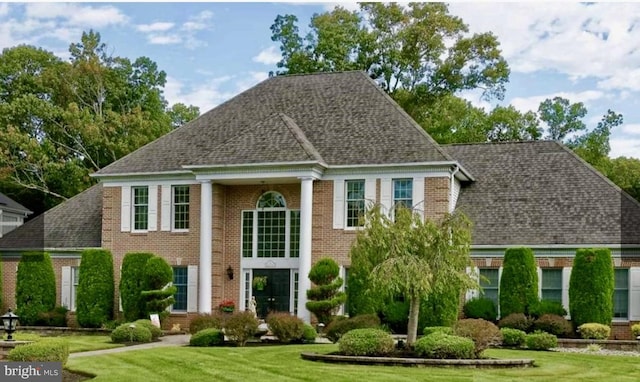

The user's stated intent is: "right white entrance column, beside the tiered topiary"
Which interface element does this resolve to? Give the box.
[298,177,313,323]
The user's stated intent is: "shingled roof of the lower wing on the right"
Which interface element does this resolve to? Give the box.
[443,141,640,245]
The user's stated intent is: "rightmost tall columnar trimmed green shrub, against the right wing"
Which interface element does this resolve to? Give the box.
[569,248,614,328]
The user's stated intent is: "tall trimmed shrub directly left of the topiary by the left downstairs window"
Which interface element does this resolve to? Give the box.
[120,252,153,321]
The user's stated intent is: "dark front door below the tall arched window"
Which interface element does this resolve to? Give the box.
[252,269,291,318]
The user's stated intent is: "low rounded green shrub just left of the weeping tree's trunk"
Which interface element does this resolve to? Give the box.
[338,328,395,356]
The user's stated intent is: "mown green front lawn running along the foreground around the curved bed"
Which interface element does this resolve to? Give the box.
[67,345,640,382]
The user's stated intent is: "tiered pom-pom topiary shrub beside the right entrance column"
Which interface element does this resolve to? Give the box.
[305,258,347,323]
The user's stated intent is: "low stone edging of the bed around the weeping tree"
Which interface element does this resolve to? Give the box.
[300,353,534,368]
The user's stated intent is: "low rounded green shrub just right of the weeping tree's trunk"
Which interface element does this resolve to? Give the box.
[414,332,474,359]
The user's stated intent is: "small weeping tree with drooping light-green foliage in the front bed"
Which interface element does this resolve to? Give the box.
[351,206,477,344]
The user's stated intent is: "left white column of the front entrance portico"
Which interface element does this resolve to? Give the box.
[198,180,213,313]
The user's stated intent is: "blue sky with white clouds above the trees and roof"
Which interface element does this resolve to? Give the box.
[0,1,640,158]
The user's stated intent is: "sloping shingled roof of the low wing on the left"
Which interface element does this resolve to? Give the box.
[0,184,102,251]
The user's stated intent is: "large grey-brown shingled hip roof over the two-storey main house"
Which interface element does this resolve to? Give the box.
[96,71,451,176]
